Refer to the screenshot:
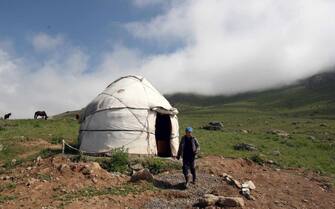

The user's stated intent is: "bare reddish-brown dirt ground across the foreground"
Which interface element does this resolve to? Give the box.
[0,155,335,209]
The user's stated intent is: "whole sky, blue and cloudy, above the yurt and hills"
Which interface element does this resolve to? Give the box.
[0,0,335,118]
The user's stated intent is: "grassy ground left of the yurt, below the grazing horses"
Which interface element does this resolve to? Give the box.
[0,119,79,163]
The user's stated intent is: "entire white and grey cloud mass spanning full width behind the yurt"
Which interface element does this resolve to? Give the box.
[0,0,335,117]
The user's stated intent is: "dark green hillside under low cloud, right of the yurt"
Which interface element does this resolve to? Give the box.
[166,71,335,118]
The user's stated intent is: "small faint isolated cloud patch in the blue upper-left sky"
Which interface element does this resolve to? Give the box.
[31,33,64,51]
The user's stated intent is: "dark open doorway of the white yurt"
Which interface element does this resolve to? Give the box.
[155,113,172,157]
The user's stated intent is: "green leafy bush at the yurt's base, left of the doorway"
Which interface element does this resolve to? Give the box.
[101,147,129,173]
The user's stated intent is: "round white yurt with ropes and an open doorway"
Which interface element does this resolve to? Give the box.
[78,75,179,157]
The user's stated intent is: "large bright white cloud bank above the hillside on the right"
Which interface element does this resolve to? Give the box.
[126,0,335,94]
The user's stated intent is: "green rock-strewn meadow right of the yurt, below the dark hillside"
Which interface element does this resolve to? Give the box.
[179,102,335,175]
